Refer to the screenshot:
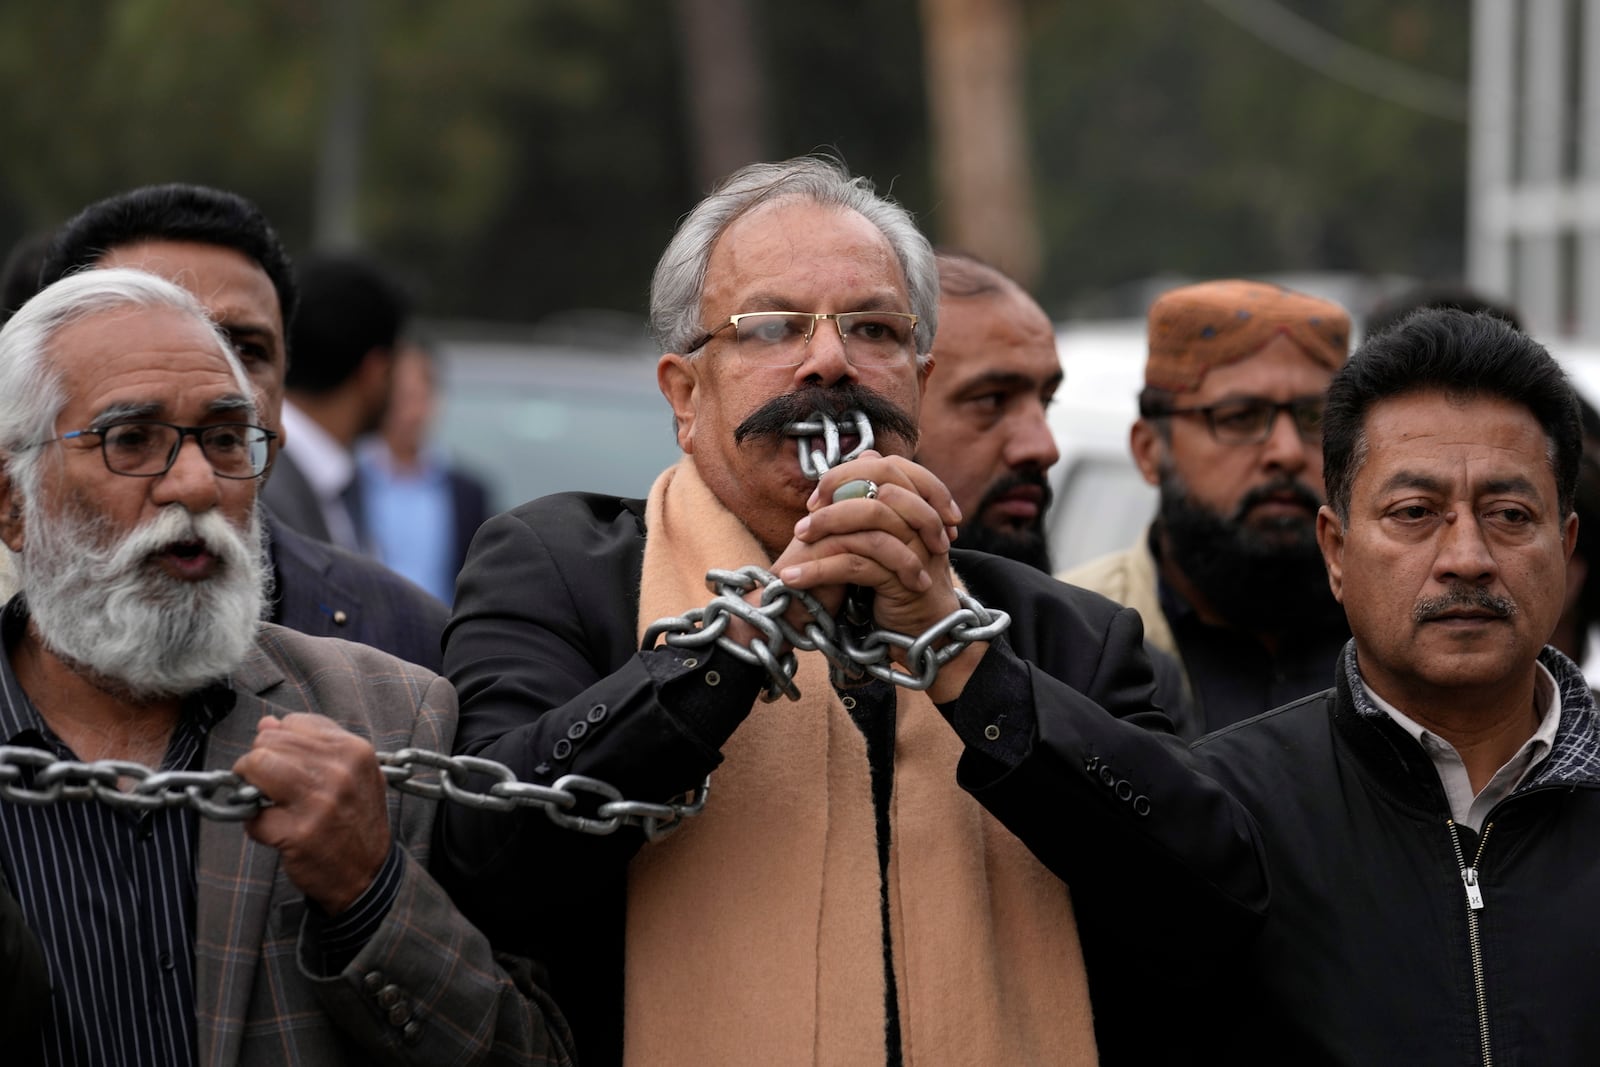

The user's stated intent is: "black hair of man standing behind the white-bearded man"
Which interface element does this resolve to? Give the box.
[38,182,298,333]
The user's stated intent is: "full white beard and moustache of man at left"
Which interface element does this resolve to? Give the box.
[16,499,267,701]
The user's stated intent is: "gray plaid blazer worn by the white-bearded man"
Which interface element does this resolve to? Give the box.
[195,624,571,1067]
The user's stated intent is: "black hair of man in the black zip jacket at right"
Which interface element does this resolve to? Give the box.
[1322,309,1584,518]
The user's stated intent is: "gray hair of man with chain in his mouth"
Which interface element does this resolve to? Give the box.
[650,155,939,363]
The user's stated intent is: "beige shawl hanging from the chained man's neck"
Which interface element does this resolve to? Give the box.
[624,459,1096,1067]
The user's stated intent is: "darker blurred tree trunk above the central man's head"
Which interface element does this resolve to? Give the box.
[677,0,768,189]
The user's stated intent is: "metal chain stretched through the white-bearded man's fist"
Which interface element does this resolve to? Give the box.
[0,745,710,841]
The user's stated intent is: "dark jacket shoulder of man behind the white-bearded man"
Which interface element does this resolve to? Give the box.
[262,511,450,673]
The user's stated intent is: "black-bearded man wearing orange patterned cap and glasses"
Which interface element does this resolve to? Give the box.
[1061,280,1350,736]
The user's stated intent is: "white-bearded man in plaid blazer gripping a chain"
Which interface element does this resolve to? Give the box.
[0,269,568,1064]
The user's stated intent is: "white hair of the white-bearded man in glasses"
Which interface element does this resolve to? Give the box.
[0,267,254,498]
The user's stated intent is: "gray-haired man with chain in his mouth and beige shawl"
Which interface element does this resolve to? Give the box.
[442,158,1165,1067]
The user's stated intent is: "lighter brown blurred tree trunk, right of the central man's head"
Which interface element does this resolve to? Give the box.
[922,0,1040,286]
